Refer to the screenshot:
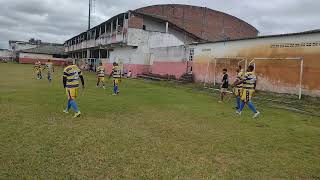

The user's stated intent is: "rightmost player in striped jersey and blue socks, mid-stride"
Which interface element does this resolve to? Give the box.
[236,65,260,118]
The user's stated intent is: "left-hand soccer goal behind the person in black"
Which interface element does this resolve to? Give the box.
[203,57,248,89]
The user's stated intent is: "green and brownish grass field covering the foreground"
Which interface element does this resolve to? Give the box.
[0,64,320,179]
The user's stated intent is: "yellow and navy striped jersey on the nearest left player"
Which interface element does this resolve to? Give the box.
[63,65,81,88]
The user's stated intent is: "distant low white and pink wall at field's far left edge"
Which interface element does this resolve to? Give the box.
[19,53,66,65]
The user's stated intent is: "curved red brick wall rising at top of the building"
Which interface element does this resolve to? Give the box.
[131,5,258,41]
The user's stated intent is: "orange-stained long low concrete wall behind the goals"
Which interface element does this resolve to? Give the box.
[190,33,320,96]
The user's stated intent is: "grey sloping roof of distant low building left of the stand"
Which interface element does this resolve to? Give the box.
[20,45,66,55]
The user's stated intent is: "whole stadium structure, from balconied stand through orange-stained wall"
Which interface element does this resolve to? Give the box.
[65,4,320,98]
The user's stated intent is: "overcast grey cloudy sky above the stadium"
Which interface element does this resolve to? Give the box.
[0,0,320,48]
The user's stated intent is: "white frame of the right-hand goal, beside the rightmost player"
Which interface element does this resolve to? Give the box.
[249,57,304,100]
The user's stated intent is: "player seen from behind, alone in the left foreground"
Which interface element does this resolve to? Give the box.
[63,62,85,118]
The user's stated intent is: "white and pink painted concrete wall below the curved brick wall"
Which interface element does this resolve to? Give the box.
[105,28,190,77]
